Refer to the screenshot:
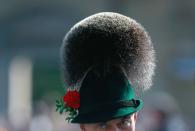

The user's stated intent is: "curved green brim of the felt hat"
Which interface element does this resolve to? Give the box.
[71,99,143,124]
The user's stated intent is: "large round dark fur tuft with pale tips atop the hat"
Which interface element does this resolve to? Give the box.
[61,12,155,90]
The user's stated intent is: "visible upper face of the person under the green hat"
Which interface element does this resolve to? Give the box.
[80,113,137,131]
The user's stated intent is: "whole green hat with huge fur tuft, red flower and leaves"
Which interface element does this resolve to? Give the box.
[57,12,155,123]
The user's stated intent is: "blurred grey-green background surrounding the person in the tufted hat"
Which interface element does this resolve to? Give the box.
[0,0,195,131]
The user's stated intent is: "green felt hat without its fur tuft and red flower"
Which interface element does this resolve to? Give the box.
[71,68,143,123]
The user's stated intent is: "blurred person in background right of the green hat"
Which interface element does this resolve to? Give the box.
[137,91,190,131]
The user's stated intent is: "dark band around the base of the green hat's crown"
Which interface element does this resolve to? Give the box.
[79,99,140,114]
